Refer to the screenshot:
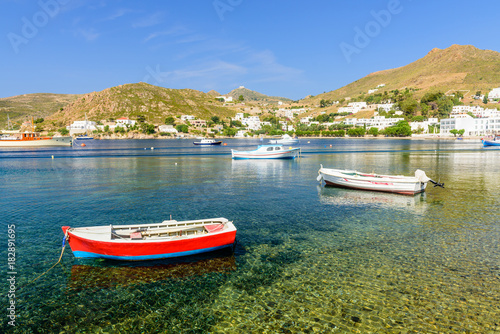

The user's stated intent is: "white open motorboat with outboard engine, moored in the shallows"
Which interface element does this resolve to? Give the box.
[317,165,444,195]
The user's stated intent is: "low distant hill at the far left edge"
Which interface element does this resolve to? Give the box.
[0,93,81,128]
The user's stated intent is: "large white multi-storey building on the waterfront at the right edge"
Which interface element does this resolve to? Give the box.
[440,117,500,136]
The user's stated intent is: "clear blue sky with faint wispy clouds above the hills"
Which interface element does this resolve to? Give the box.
[0,0,500,99]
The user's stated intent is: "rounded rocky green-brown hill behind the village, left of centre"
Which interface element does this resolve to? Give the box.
[47,82,240,126]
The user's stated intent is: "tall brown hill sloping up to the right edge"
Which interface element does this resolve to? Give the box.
[301,45,500,104]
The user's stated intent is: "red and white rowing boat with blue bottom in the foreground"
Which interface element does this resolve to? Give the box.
[62,218,236,261]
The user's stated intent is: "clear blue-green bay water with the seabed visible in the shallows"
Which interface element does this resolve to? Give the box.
[0,139,500,333]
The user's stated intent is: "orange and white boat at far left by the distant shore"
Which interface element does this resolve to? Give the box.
[0,132,73,147]
